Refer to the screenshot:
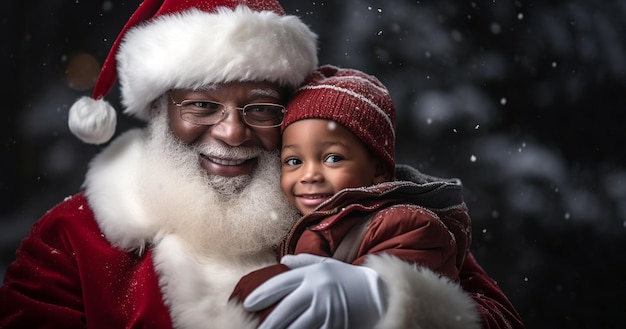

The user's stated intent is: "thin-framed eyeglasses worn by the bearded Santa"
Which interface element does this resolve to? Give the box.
[169,93,285,128]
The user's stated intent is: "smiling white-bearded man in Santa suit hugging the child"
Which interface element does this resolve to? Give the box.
[0,0,521,328]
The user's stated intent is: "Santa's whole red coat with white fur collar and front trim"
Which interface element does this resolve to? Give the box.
[0,130,523,328]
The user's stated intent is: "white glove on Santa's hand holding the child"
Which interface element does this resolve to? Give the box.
[243,254,387,329]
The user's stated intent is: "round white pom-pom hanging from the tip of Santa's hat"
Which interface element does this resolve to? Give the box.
[67,96,117,144]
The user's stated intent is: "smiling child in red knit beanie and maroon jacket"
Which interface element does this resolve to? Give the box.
[232,65,470,326]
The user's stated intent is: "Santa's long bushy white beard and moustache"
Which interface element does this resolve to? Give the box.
[139,104,298,258]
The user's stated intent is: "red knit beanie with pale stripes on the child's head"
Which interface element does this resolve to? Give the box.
[281,65,396,177]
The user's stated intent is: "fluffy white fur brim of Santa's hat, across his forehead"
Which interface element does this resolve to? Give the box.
[117,6,317,120]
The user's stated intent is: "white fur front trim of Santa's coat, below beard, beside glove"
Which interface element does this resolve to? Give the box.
[154,234,275,329]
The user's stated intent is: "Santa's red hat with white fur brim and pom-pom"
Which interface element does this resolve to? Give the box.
[68,0,317,144]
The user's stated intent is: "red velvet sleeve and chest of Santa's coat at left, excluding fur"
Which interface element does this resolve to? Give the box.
[0,194,172,329]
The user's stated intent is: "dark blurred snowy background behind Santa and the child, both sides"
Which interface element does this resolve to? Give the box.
[0,0,626,328]
